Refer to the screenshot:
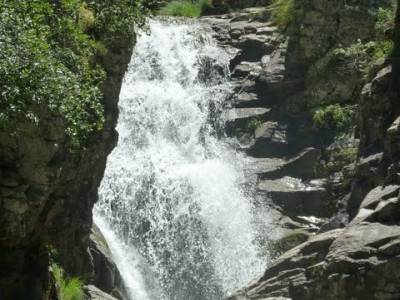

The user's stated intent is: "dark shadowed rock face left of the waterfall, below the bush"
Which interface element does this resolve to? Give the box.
[0,14,133,300]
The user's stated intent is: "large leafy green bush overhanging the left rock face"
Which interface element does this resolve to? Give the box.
[0,0,146,147]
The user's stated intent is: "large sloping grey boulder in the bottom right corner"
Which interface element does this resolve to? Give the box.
[229,223,400,300]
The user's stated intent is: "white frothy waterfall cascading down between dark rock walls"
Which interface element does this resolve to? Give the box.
[94,21,265,300]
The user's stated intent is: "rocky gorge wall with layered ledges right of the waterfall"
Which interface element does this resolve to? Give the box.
[203,0,400,300]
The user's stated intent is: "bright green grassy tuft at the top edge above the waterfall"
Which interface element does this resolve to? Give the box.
[159,0,212,18]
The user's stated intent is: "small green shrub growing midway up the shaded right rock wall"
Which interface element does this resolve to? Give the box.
[313,104,354,131]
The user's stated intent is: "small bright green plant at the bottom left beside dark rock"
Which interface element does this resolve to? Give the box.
[51,263,85,300]
